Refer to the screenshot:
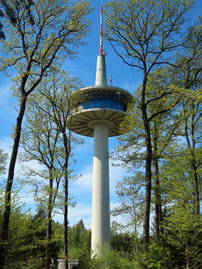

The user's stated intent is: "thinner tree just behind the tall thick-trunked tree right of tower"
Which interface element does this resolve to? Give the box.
[112,68,183,242]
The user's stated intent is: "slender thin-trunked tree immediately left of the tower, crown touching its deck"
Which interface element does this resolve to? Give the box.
[26,72,82,268]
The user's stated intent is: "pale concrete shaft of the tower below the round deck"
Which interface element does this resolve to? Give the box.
[91,123,110,256]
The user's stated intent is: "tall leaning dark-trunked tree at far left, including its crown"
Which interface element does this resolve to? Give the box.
[0,0,90,268]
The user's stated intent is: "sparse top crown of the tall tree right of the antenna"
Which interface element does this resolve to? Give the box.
[105,0,193,69]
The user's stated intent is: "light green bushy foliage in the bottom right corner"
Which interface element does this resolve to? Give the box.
[163,202,202,268]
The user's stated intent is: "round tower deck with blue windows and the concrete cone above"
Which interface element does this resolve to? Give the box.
[68,55,132,137]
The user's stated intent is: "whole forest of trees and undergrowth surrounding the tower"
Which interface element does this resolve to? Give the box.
[0,0,202,269]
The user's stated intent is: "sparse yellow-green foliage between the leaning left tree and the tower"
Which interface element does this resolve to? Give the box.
[21,71,80,209]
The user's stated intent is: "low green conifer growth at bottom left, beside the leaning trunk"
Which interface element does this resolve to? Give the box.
[0,188,49,269]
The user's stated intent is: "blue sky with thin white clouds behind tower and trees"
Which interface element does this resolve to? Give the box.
[0,0,202,228]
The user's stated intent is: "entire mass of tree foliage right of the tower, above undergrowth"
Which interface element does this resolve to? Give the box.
[105,0,202,248]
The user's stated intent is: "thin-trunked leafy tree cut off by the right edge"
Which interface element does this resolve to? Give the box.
[175,18,202,215]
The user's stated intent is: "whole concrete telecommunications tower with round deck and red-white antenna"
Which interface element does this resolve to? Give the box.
[69,1,132,256]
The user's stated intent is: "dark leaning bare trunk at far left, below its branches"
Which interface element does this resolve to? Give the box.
[0,94,27,269]
